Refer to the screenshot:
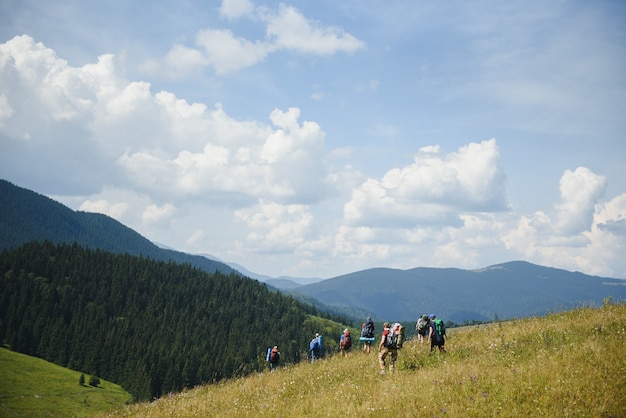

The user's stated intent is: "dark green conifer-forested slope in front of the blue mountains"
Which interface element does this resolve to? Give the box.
[0,242,343,399]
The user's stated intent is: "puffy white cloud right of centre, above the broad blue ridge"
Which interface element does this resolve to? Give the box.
[344,139,507,226]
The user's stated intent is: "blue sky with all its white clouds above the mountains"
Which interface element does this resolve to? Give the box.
[0,0,626,279]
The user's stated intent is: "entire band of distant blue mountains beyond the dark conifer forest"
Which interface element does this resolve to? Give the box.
[0,180,626,323]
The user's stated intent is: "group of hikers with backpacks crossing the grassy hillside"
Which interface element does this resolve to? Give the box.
[267,314,446,374]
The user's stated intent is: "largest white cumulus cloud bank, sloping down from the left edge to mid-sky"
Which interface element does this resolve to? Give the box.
[0,37,331,206]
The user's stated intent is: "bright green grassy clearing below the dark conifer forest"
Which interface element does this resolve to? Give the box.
[0,348,131,417]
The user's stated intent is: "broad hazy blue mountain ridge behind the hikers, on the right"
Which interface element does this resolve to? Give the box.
[296,261,626,323]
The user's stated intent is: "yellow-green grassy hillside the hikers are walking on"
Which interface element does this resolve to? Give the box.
[102,304,626,417]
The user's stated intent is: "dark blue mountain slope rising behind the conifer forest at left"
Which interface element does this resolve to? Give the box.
[0,180,236,274]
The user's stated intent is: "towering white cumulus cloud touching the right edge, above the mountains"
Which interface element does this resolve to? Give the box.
[502,167,626,277]
